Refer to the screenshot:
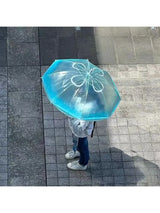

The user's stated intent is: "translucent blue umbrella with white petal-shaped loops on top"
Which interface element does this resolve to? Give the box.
[42,59,121,120]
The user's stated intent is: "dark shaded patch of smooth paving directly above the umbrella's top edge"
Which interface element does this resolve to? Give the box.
[38,27,98,66]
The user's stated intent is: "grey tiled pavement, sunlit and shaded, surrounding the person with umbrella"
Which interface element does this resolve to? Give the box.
[0,27,160,186]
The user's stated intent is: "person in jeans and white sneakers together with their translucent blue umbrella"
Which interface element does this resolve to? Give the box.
[42,59,121,170]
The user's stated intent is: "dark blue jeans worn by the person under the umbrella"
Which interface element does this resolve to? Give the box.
[73,135,89,166]
